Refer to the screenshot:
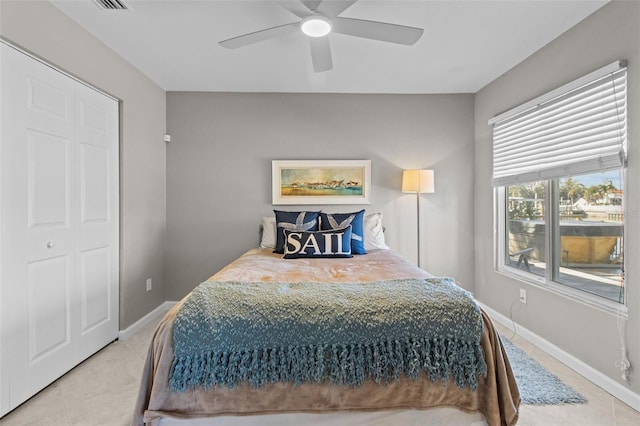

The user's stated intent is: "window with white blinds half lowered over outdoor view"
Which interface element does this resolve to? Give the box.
[490,61,626,304]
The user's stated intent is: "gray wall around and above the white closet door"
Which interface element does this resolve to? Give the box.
[0,0,166,329]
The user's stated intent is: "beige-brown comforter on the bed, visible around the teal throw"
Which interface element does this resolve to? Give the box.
[133,249,520,425]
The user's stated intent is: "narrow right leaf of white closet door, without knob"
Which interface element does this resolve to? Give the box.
[75,79,119,359]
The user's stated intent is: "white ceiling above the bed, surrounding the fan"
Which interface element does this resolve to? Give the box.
[50,0,608,93]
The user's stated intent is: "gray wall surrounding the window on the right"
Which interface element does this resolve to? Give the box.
[475,1,640,393]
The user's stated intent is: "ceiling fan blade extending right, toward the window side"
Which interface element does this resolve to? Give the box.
[332,18,424,46]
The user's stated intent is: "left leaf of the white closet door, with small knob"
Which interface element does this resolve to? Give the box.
[0,44,79,413]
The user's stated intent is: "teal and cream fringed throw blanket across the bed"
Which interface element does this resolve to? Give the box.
[170,278,487,391]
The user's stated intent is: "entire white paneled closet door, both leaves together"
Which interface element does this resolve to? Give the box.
[0,43,118,415]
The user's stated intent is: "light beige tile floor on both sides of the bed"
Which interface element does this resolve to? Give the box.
[0,312,640,426]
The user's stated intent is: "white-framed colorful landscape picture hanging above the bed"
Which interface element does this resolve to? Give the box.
[271,160,371,205]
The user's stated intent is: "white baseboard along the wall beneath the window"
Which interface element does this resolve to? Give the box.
[480,303,640,411]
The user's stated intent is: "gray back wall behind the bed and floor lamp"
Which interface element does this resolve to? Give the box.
[167,92,474,300]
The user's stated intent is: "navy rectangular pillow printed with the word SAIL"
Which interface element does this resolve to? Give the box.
[283,226,352,259]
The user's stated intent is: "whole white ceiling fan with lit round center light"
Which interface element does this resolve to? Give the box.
[219,0,424,72]
